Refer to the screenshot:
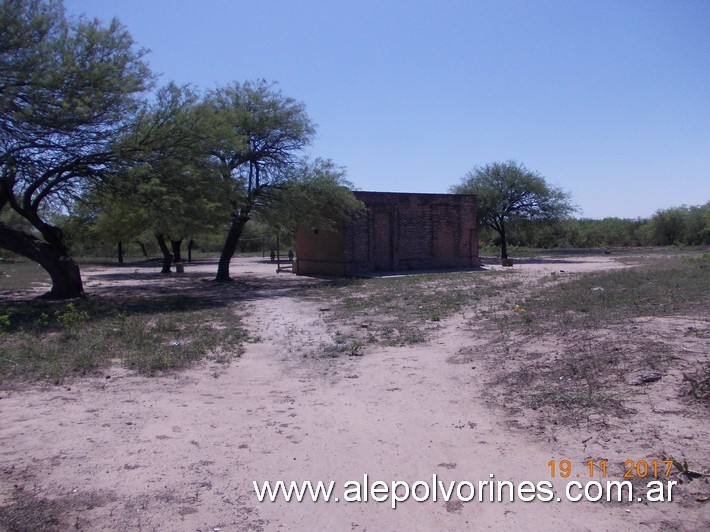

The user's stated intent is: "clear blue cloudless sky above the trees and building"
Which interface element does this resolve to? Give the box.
[65,0,710,218]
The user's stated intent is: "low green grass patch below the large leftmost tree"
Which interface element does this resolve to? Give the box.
[0,296,246,383]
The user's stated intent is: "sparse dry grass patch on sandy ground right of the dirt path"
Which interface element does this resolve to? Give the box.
[478,254,710,501]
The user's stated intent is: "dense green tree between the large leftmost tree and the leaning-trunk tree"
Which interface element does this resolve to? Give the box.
[106,83,229,273]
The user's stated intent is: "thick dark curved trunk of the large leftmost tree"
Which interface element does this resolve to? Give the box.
[0,222,84,299]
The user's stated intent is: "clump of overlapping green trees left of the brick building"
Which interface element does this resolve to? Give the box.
[0,0,356,298]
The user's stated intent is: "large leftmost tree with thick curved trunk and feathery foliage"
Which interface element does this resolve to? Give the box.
[0,0,151,298]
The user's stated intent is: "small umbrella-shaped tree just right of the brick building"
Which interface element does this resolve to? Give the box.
[451,161,576,259]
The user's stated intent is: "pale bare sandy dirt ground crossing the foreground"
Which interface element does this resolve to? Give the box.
[0,257,710,532]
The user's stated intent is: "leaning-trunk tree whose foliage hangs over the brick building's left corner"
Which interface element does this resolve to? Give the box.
[205,80,364,282]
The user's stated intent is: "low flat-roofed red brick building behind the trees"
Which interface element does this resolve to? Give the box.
[295,192,480,275]
